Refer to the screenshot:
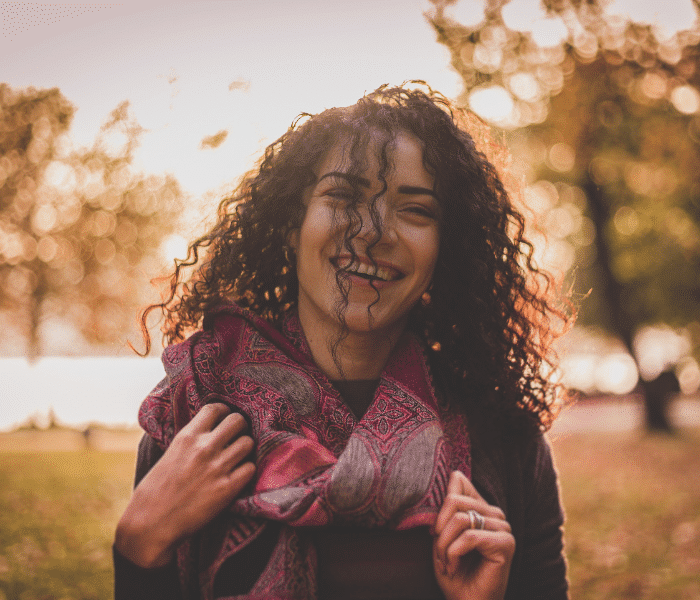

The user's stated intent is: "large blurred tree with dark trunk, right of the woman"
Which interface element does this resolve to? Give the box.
[429,0,700,431]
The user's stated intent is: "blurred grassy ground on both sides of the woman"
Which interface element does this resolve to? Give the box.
[0,429,700,600]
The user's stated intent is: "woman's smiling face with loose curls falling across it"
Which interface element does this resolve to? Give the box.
[290,133,440,334]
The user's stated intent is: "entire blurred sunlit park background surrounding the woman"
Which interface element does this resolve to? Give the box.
[0,0,700,600]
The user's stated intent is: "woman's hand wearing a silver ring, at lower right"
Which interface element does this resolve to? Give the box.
[433,471,515,600]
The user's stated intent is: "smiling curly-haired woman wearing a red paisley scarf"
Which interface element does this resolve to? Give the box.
[114,84,567,600]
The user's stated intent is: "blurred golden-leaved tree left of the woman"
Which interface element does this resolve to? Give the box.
[0,84,182,359]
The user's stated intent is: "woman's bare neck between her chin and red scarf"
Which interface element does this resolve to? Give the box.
[299,306,403,380]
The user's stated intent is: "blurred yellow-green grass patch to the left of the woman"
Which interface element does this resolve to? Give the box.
[0,450,134,600]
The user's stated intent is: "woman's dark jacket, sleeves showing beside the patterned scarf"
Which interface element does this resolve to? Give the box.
[115,434,568,600]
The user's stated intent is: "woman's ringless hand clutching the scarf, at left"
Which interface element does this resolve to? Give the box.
[114,404,255,568]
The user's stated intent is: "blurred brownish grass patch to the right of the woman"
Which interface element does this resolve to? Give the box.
[553,429,700,600]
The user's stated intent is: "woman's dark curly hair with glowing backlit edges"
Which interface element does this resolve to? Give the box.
[142,82,573,430]
